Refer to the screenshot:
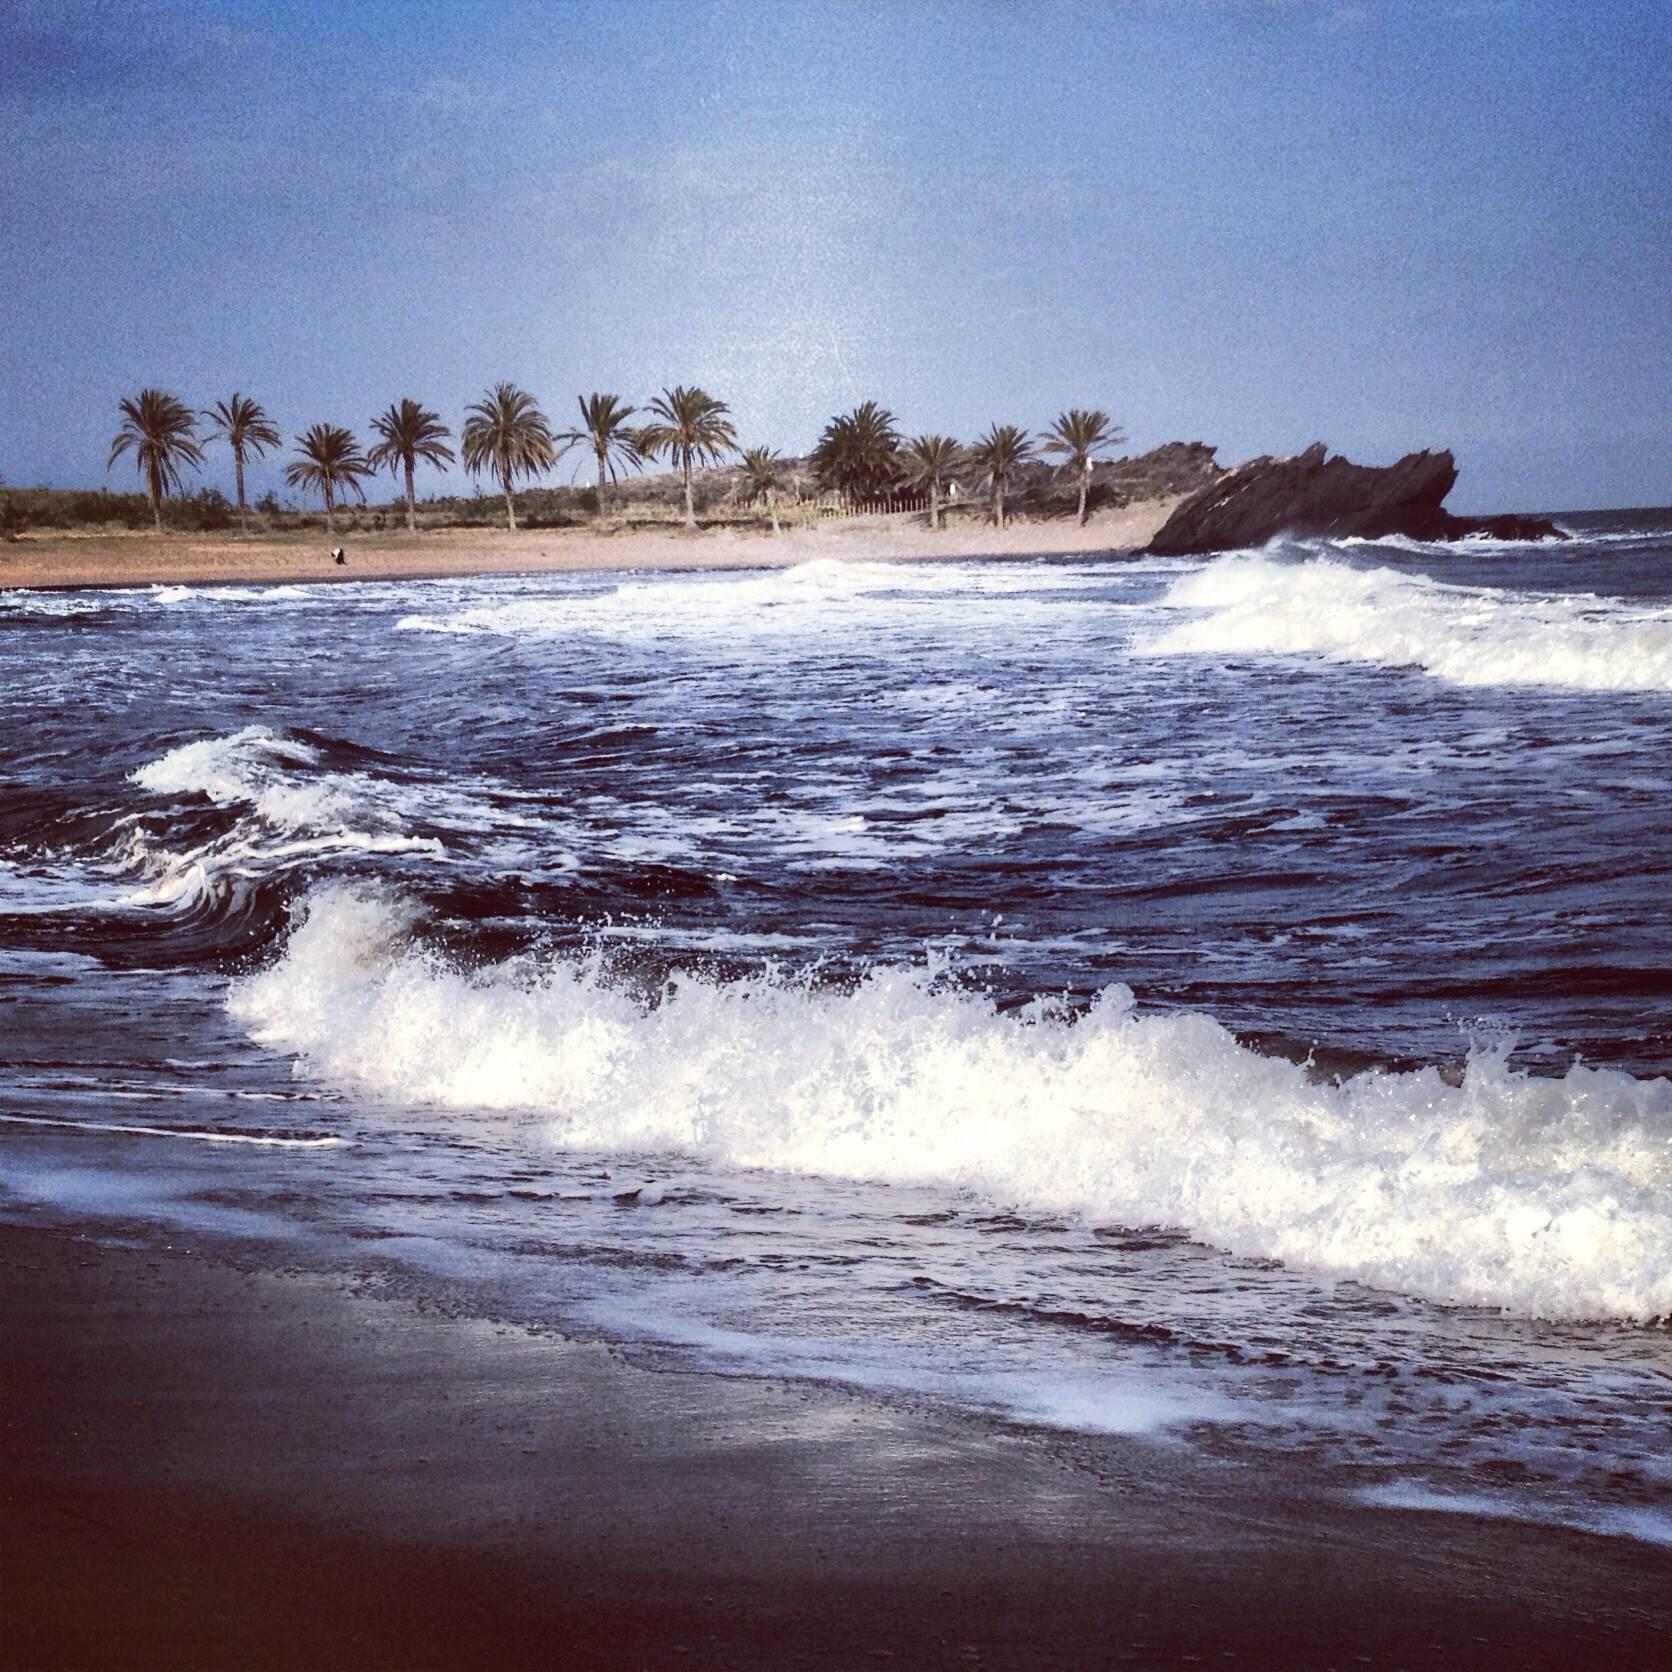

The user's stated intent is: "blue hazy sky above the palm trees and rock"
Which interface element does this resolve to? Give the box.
[0,0,1672,512]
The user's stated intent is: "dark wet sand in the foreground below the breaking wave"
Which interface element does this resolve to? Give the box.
[0,1229,1672,1672]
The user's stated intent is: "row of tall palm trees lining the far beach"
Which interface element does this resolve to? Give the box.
[105,383,1125,533]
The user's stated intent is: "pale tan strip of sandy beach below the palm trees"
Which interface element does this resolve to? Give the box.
[0,500,1177,587]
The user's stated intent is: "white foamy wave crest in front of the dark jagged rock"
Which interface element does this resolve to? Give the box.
[1145,553,1672,691]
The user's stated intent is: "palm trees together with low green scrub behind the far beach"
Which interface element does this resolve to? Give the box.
[88,383,1190,535]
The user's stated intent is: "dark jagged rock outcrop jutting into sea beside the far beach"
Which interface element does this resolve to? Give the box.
[1149,441,1562,557]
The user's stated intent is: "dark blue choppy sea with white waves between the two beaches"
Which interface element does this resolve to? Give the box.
[0,512,1672,1543]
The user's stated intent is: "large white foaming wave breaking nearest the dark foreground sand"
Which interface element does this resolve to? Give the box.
[231,884,1672,1319]
